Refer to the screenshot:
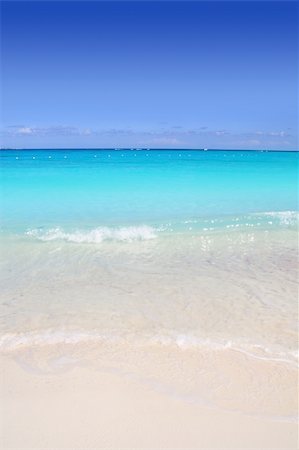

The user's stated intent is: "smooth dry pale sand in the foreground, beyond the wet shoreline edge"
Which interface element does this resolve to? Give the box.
[0,355,298,450]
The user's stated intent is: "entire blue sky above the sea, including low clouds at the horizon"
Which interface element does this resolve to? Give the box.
[1,0,298,149]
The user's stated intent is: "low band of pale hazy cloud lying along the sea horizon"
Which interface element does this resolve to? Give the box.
[1,124,297,149]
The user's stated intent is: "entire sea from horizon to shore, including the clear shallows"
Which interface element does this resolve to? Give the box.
[0,149,298,390]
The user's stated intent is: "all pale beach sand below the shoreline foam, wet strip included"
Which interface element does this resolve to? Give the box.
[0,342,298,450]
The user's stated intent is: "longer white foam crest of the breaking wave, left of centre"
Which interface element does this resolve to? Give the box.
[26,225,157,244]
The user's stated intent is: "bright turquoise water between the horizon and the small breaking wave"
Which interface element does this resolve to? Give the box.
[0,150,298,231]
